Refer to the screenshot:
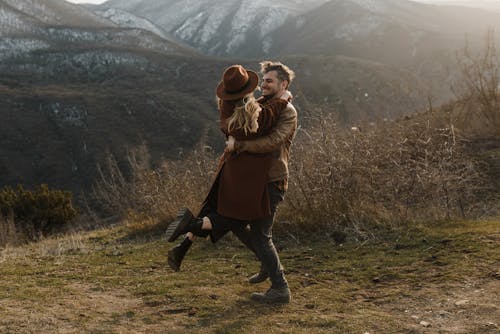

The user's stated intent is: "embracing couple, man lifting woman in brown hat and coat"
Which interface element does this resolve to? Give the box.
[166,61,297,303]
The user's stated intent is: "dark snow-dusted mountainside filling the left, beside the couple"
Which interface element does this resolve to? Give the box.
[0,0,215,192]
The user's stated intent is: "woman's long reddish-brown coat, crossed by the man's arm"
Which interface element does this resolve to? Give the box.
[199,99,287,221]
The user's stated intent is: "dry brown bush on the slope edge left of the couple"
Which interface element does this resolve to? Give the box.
[92,146,217,221]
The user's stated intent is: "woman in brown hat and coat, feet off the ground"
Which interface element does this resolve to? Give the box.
[166,65,291,271]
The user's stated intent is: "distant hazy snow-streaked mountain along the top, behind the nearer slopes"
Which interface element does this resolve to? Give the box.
[94,0,500,67]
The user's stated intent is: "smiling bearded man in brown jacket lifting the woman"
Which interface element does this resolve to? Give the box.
[226,61,297,303]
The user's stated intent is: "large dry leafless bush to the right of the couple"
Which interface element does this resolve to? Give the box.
[280,110,488,236]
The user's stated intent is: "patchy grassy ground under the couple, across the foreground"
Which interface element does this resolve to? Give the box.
[0,221,500,333]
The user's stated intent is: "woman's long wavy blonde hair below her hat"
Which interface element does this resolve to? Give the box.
[227,93,262,134]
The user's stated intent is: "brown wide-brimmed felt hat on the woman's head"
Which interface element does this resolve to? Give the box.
[217,65,259,101]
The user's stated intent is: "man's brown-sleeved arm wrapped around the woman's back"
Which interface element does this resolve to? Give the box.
[234,104,297,153]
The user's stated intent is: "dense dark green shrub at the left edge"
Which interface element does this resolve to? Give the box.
[0,184,78,240]
